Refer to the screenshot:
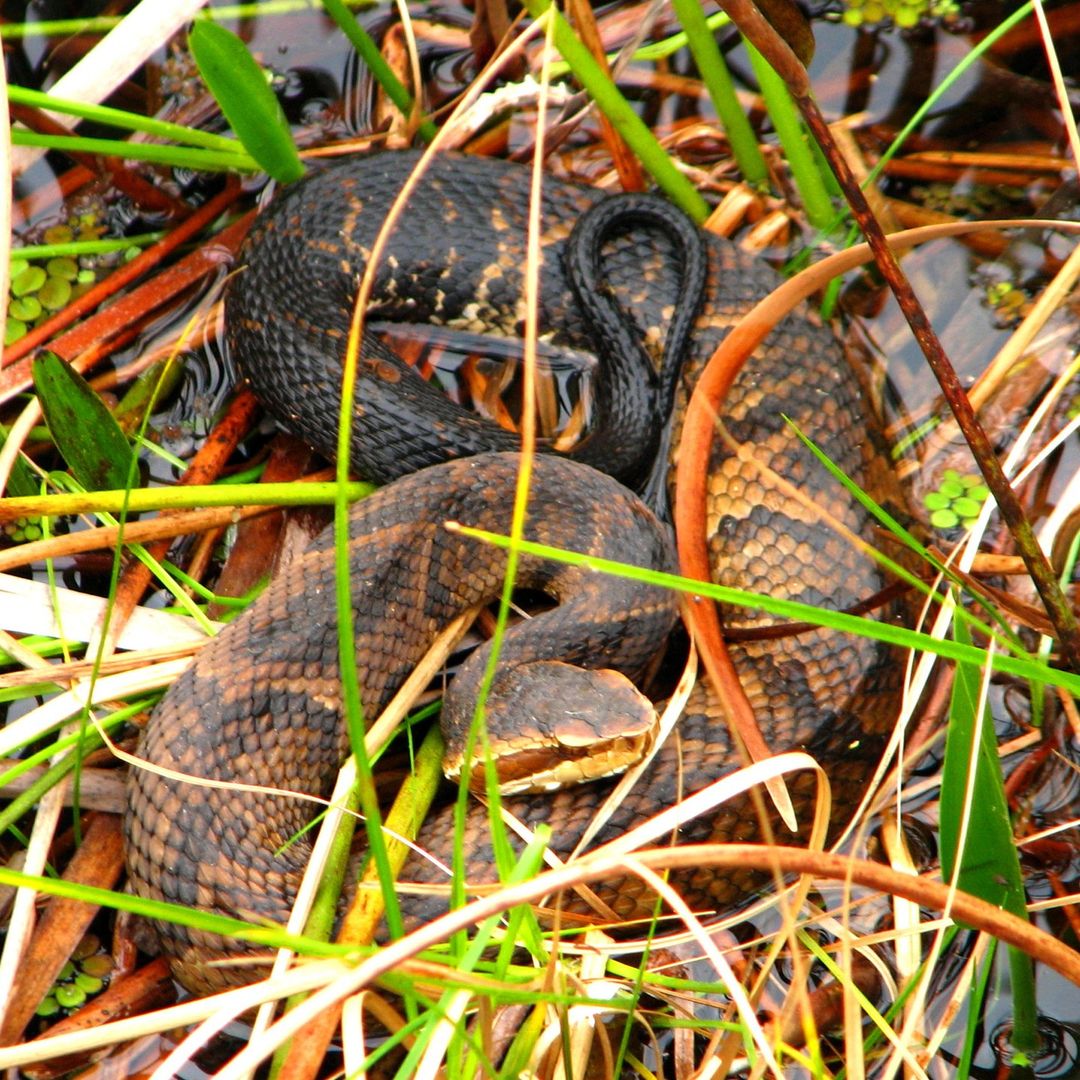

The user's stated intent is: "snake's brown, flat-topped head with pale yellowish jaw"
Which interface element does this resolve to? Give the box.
[443,660,658,795]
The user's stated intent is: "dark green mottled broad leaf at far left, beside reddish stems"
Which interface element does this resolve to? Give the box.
[33,352,132,491]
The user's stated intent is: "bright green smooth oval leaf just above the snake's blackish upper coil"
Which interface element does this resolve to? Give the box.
[188,21,303,184]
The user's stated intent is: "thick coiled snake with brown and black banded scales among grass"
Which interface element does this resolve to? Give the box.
[125,151,901,989]
